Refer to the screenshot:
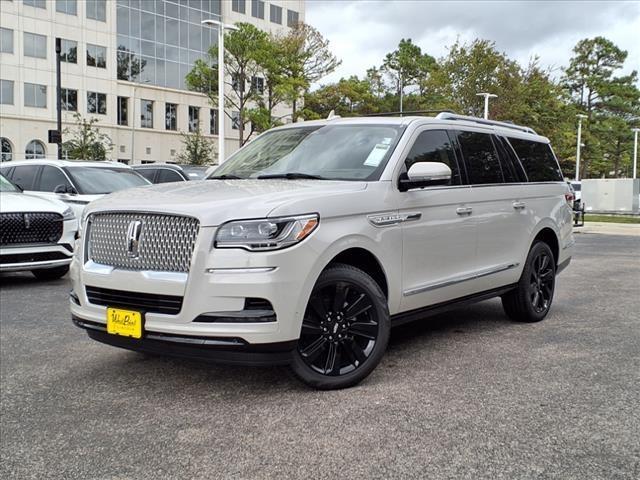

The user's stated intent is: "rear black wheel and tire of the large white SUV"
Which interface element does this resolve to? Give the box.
[502,241,556,322]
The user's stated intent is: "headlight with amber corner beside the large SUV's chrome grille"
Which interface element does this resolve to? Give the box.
[213,214,320,251]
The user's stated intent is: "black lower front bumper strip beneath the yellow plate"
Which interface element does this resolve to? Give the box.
[72,315,297,366]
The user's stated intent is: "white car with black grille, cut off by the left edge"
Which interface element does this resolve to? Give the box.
[0,175,78,280]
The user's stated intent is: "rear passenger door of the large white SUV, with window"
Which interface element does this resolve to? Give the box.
[457,130,533,290]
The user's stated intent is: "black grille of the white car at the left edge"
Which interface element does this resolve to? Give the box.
[0,212,63,246]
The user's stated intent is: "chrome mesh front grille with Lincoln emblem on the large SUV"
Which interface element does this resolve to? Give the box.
[87,212,199,272]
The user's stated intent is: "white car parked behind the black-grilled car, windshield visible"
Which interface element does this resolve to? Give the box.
[0,159,150,218]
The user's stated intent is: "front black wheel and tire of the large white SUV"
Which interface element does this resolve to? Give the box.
[291,264,391,390]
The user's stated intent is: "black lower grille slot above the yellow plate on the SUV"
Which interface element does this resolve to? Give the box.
[86,286,182,315]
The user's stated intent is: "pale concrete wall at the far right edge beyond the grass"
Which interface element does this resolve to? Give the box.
[582,178,640,214]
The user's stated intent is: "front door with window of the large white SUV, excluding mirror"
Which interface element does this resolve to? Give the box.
[398,127,477,311]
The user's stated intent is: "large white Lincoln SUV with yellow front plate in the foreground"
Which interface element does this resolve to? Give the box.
[70,113,574,389]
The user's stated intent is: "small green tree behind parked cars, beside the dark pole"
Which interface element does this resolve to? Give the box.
[62,113,113,160]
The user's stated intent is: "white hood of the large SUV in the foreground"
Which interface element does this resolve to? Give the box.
[85,179,367,226]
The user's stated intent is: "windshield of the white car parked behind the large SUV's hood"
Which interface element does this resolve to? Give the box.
[65,167,149,195]
